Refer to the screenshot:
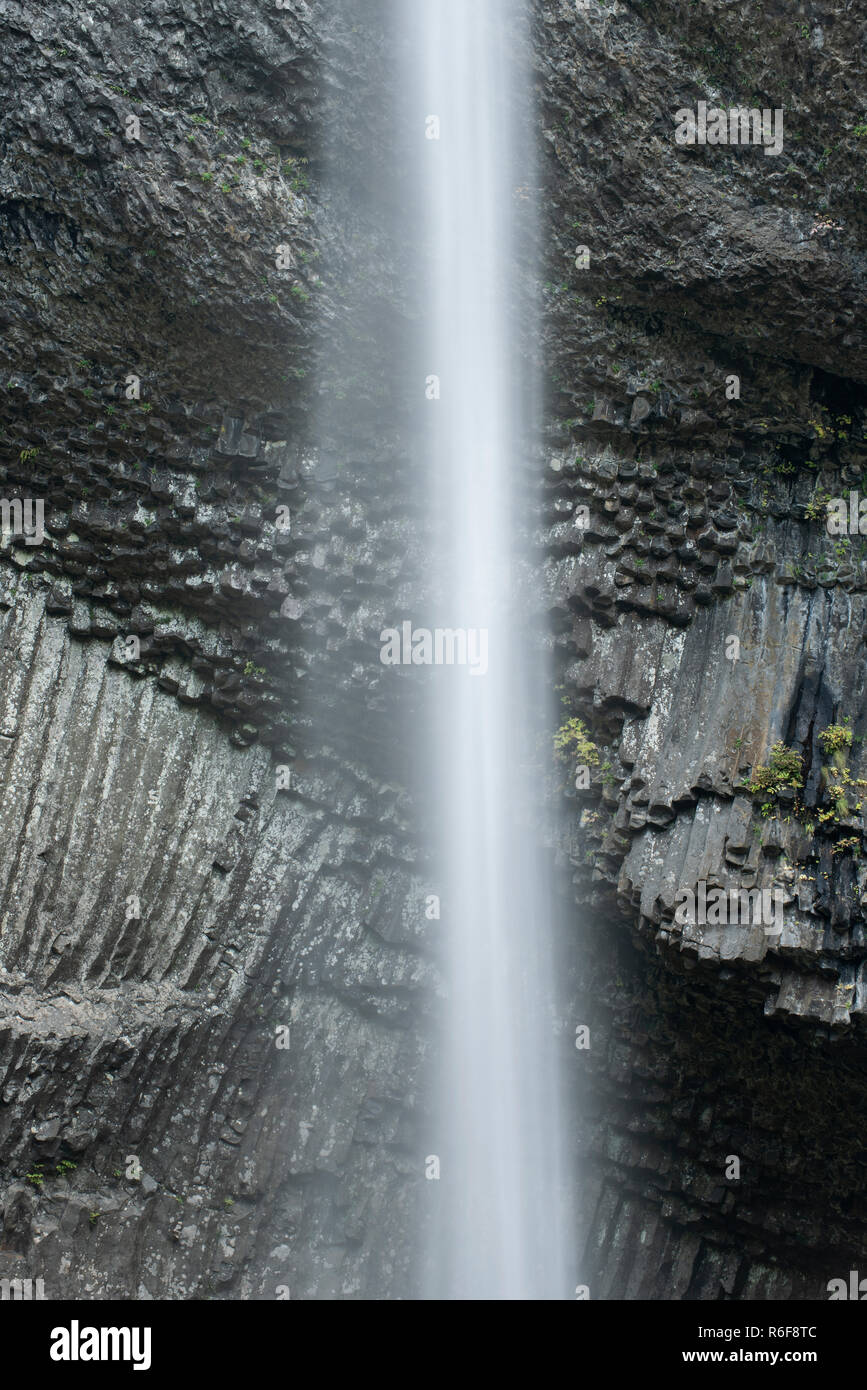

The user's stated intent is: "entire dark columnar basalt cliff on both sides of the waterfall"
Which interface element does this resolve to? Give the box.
[0,0,867,1300]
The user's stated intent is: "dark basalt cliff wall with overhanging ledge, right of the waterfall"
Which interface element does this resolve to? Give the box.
[536,3,867,1298]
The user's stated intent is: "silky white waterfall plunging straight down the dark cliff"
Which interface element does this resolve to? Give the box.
[397,0,570,1298]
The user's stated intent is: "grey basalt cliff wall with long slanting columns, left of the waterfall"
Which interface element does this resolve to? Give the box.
[0,0,434,1300]
